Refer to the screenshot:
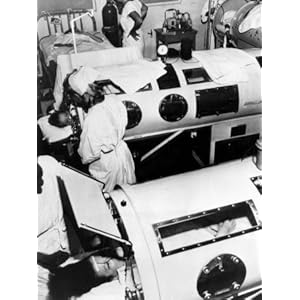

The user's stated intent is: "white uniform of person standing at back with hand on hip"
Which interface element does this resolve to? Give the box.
[120,0,144,55]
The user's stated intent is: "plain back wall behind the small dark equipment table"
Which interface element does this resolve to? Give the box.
[95,0,206,59]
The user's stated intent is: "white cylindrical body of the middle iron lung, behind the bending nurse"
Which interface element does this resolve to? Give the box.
[117,49,262,140]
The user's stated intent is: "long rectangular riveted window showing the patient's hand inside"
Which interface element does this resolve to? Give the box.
[153,200,261,256]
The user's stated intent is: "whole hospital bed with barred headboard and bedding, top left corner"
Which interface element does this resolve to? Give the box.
[37,9,114,88]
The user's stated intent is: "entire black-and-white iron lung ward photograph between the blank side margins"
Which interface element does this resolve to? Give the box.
[35,0,264,300]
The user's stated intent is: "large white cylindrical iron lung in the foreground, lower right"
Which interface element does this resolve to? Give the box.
[111,158,262,300]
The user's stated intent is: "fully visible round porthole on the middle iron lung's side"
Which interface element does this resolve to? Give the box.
[159,94,188,122]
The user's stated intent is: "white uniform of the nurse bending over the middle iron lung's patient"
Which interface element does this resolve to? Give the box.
[78,95,135,192]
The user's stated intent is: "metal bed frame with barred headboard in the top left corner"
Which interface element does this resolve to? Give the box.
[37,9,97,89]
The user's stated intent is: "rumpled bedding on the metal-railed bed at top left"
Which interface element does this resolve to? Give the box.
[40,33,114,66]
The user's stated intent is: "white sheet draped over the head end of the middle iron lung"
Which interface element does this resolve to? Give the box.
[54,47,166,108]
